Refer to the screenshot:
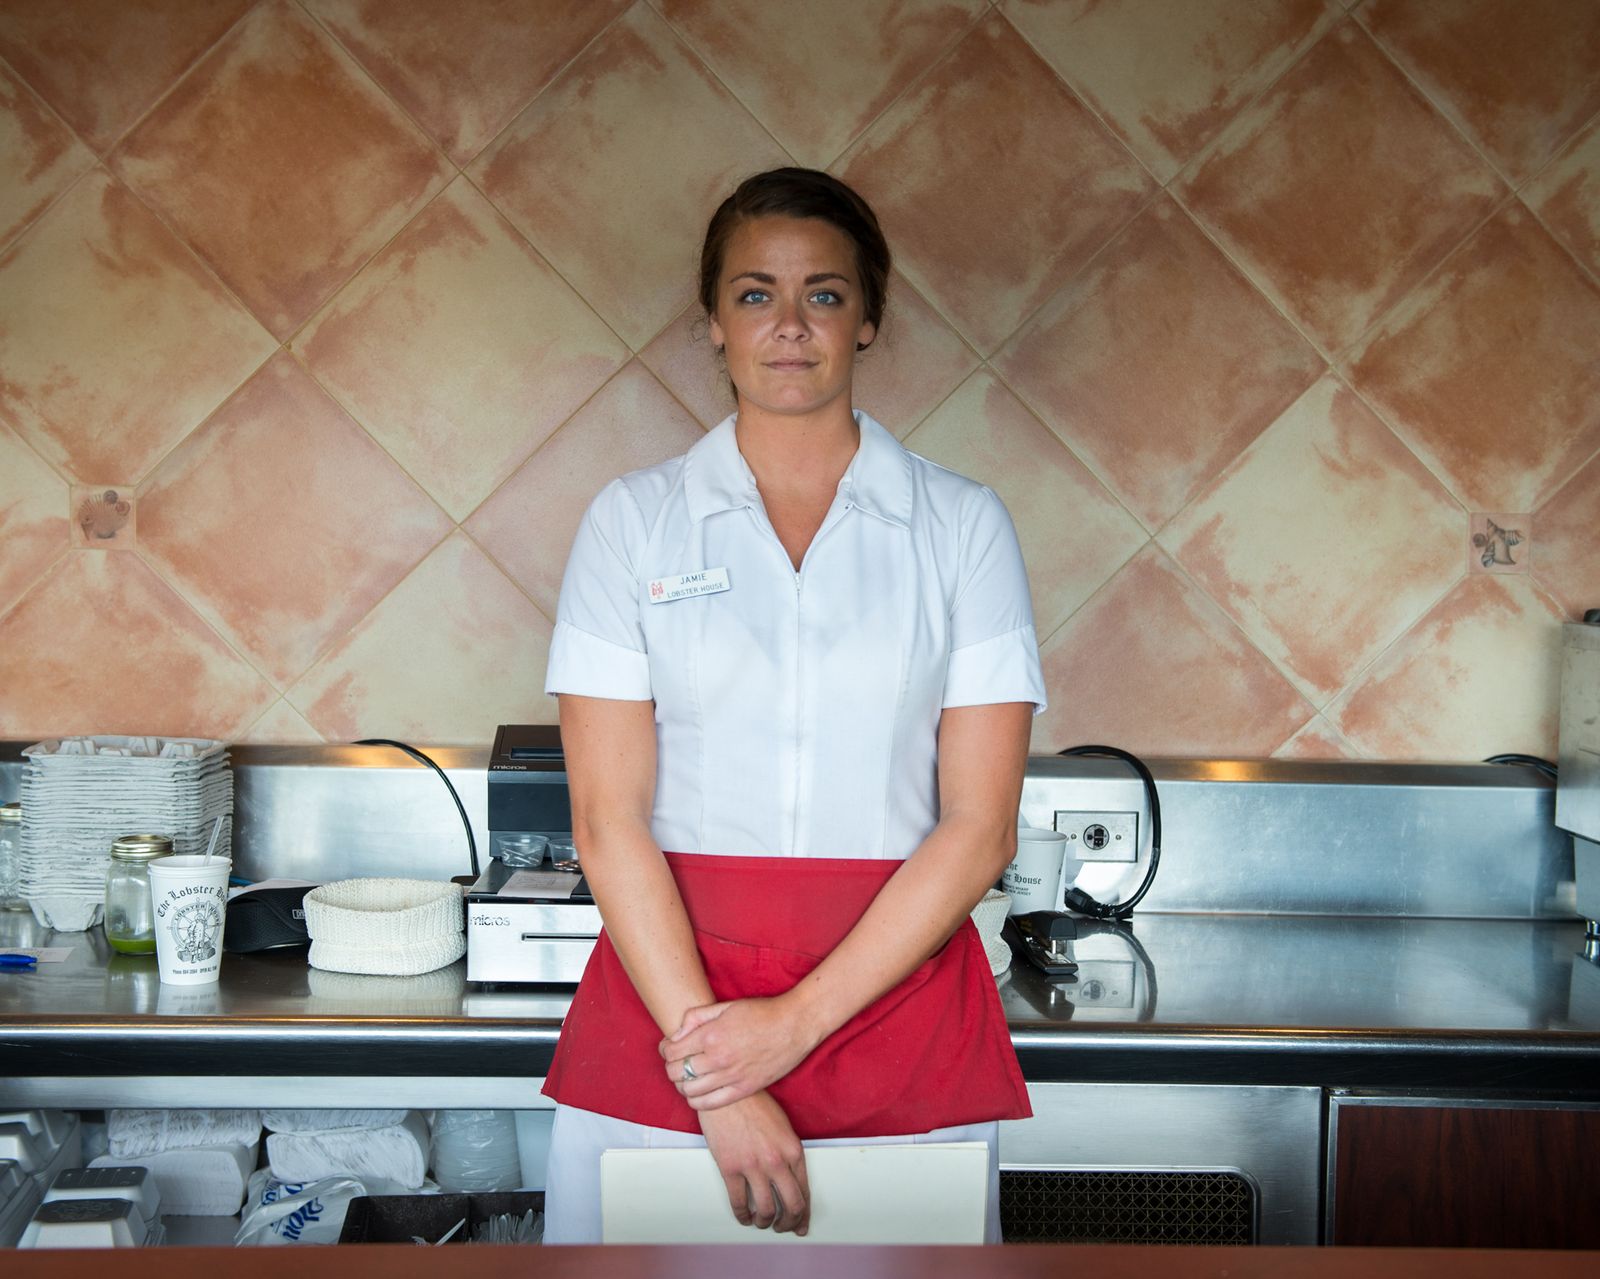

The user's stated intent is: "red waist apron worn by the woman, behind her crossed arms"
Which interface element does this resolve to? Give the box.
[544,853,1032,1138]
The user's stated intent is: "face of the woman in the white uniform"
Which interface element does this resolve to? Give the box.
[710,216,877,415]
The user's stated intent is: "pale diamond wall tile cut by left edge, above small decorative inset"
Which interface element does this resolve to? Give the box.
[0,171,274,483]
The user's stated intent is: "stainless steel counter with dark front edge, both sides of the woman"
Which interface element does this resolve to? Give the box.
[0,914,1600,1106]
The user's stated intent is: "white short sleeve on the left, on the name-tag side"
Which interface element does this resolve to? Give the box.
[544,480,653,701]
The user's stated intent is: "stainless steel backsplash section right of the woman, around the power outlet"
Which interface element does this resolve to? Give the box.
[1022,756,1574,919]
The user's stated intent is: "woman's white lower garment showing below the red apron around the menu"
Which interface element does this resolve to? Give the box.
[544,1106,1000,1244]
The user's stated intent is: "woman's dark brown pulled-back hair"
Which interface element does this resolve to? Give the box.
[699,168,890,351]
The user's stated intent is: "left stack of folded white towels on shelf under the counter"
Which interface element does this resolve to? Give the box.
[90,1109,261,1217]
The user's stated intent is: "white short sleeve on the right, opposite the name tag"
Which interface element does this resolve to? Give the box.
[942,488,1046,714]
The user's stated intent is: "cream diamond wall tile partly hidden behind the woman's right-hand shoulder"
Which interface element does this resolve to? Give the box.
[906,370,1147,637]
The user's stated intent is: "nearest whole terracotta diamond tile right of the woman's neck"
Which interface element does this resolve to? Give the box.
[995,197,1326,528]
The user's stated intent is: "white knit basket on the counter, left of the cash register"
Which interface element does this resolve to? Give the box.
[306,879,467,976]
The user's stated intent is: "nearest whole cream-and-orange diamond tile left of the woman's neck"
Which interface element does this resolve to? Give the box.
[296,179,629,520]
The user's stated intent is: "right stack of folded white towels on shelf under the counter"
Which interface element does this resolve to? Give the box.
[261,1109,430,1191]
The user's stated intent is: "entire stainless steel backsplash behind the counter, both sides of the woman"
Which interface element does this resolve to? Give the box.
[0,743,1574,919]
